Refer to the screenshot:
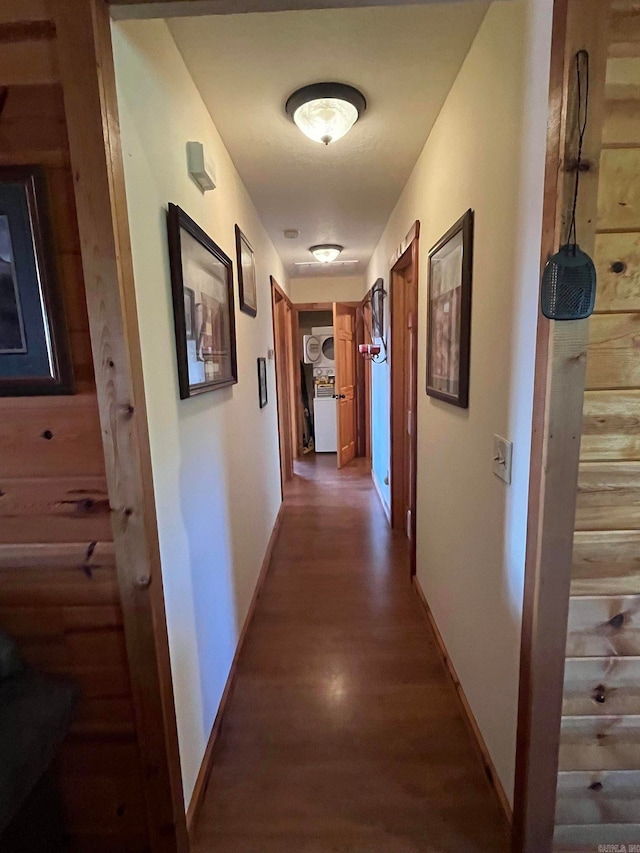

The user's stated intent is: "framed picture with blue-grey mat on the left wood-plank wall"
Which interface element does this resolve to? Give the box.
[0,166,73,397]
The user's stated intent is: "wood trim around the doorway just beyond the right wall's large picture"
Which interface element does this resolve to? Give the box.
[389,226,420,577]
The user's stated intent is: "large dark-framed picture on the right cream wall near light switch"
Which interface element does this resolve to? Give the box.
[427,210,473,409]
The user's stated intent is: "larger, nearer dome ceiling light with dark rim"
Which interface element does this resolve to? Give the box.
[285,83,367,145]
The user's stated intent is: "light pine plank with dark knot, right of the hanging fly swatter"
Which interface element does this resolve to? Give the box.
[595,233,640,312]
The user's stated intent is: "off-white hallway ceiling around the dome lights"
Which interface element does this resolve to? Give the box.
[167,0,490,276]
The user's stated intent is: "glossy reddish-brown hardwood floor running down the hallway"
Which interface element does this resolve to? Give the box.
[194,456,508,853]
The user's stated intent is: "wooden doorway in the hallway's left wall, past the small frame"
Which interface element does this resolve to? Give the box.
[271,278,294,490]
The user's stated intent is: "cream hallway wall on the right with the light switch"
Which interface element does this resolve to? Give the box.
[367,0,552,797]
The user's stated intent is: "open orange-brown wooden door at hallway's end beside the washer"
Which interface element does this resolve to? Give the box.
[333,302,357,468]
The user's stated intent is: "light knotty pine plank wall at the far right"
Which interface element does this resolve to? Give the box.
[556,2,640,851]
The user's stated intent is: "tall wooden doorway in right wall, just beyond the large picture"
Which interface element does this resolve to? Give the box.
[390,222,420,575]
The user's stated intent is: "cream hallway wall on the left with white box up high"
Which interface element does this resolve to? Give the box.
[113,21,287,803]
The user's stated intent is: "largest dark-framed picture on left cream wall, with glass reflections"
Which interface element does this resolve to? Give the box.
[167,204,238,400]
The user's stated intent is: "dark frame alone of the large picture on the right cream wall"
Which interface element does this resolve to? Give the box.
[426,210,474,409]
